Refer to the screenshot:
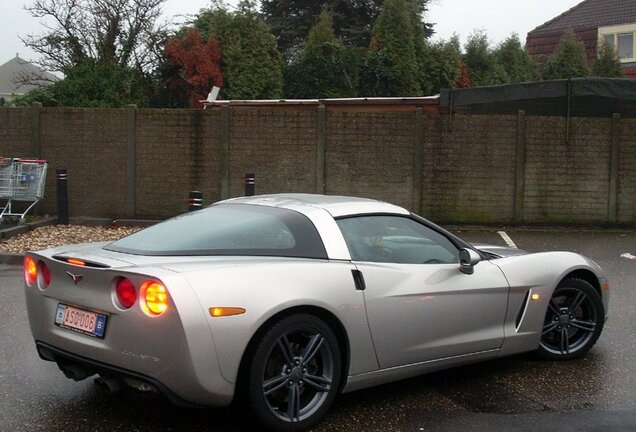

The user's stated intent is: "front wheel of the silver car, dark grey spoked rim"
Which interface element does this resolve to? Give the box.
[537,278,605,360]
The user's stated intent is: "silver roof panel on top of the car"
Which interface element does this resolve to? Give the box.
[220,194,410,218]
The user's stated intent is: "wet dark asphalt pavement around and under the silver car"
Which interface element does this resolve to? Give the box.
[0,230,636,432]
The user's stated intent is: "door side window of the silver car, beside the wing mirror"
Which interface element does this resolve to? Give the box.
[337,216,459,264]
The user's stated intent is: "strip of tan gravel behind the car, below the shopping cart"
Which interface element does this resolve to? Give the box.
[0,225,142,253]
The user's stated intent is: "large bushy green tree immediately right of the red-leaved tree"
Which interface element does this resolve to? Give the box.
[193,0,283,99]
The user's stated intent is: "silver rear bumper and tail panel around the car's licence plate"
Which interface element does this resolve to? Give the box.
[25,255,235,406]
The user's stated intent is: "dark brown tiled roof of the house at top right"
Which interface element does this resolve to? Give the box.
[528,0,636,37]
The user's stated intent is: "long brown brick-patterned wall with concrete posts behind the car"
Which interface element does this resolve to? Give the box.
[0,104,636,226]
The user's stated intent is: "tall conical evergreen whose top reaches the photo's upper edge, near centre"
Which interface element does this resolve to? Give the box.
[360,0,422,96]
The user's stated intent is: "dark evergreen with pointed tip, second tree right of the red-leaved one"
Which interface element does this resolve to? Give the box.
[285,8,357,98]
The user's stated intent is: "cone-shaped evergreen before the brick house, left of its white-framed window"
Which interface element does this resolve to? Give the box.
[543,30,590,80]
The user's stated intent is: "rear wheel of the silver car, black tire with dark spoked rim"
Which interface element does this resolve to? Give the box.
[247,314,342,431]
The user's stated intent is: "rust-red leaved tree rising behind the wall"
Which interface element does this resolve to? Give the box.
[166,29,223,108]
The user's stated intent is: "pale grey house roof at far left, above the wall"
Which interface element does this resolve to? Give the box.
[0,55,59,96]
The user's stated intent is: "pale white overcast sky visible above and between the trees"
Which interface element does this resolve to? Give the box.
[0,0,581,64]
